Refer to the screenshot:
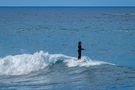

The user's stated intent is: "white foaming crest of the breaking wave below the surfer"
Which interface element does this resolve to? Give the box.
[0,51,113,75]
